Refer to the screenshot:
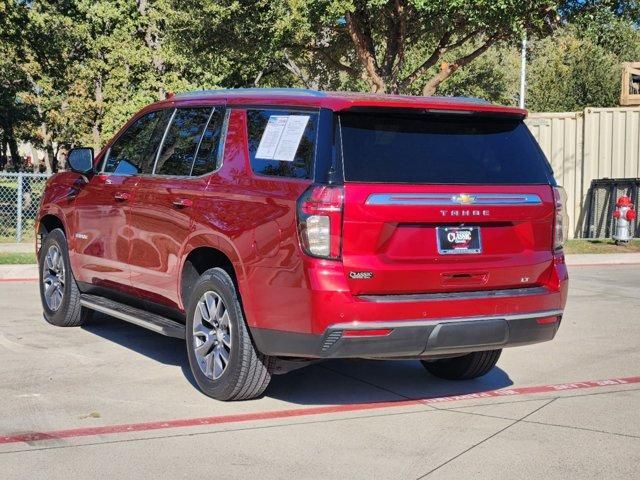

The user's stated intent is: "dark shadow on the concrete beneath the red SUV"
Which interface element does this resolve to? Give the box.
[82,314,513,405]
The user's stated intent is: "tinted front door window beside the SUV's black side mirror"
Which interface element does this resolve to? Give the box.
[104,110,172,175]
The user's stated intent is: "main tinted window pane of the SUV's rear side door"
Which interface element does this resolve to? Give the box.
[155,107,212,175]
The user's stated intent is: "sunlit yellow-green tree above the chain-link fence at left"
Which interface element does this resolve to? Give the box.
[2,0,205,163]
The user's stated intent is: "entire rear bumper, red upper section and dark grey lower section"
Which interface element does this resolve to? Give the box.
[249,255,569,358]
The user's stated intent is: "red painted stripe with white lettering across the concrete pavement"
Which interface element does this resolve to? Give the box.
[0,376,640,444]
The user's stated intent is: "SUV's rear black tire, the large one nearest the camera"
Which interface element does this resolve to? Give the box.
[185,268,272,401]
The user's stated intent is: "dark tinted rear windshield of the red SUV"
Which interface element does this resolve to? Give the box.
[340,113,551,184]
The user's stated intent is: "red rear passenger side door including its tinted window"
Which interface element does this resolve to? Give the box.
[129,106,224,308]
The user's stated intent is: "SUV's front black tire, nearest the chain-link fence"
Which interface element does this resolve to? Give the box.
[38,228,92,327]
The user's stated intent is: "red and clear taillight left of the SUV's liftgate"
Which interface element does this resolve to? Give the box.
[298,185,344,259]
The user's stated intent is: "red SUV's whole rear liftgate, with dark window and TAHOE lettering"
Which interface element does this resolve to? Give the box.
[340,111,555,294]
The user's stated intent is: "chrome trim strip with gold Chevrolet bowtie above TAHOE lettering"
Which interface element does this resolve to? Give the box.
[366,193,542,206]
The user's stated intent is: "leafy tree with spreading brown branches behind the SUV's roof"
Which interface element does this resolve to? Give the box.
[170,0,558,95]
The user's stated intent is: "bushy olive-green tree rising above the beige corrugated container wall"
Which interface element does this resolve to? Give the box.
[528,0,640,111]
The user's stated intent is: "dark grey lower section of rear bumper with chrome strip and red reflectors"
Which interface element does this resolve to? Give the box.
[252,310,562,358]
